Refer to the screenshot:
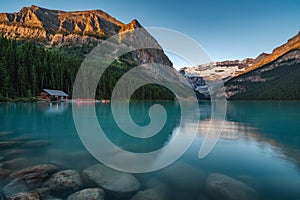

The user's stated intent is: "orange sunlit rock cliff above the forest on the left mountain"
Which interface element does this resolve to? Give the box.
[0,6,124,44]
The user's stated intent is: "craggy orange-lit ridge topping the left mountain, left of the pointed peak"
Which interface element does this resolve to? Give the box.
[0,5,126,39]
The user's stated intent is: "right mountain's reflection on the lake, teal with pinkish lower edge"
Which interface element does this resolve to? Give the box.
[199,101,300,167]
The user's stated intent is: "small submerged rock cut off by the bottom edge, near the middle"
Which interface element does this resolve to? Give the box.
[131,188,169,200]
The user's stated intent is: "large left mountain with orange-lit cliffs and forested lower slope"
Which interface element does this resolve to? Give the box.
[0,6,189,101]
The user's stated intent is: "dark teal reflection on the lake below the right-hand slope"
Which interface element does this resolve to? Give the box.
[227,101,300,166]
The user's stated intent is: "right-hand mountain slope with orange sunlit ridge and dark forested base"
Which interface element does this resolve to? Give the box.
[225,32,300,100]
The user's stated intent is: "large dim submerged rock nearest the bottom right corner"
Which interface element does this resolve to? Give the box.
[206,174,257,200]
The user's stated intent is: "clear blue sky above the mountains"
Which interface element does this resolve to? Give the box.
[0,0,300,68]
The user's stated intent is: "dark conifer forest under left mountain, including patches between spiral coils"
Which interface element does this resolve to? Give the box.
[0,37,175,100]
